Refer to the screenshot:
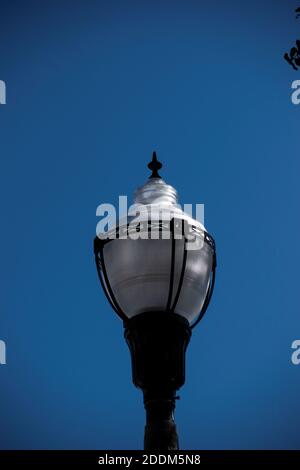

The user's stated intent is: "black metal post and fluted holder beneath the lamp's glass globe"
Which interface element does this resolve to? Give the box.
[124,312,191,451]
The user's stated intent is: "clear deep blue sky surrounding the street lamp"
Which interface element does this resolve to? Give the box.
[0,0,300,449]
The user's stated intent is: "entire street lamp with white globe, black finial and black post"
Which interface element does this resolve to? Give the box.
[94,152,216,451]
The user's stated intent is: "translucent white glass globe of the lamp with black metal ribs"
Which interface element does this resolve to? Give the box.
[95,158,216,326]
